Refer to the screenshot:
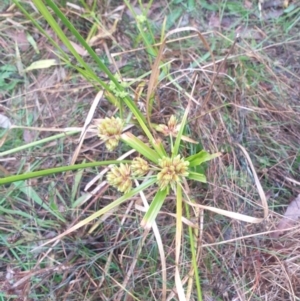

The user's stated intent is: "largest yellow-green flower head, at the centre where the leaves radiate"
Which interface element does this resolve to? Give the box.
[157,155,189,189]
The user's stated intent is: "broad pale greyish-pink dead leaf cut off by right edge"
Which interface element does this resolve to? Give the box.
[272,194,300,238]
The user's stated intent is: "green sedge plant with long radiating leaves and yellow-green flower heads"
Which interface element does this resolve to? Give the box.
[0,0,268,300]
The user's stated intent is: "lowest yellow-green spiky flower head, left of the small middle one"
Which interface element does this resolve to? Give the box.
[106,163,132,193]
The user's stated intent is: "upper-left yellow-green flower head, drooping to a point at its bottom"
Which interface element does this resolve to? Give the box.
[98,117,124,151]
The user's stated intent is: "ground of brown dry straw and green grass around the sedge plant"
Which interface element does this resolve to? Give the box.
[0,0,300,301]
